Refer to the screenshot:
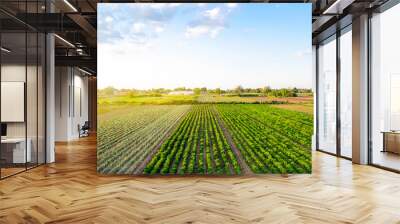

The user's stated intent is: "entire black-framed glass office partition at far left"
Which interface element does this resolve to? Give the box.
[0,1,46,179]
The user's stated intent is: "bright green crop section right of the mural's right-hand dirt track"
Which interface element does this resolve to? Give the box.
[217,105,312,173]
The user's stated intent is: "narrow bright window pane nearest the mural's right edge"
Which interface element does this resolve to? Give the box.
[317,36,336,153]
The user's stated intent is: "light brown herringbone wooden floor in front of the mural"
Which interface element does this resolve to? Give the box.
[0,137,400,224]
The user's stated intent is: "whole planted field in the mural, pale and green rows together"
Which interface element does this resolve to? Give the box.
[98,100,313,175]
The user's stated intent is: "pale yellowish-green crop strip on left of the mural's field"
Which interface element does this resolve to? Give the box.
[97,105,191,174]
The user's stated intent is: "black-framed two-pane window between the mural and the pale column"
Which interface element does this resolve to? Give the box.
[316,23,352,160]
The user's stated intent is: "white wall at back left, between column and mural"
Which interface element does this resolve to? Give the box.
[55,67,88,141]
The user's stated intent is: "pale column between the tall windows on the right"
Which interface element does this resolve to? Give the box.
[352,14,368,164]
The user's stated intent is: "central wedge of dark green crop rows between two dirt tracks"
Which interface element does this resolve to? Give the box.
[144,105,241,174]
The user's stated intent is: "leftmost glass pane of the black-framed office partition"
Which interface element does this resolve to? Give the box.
[0,32,27,177]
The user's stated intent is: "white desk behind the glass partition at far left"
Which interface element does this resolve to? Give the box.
[1,138,32,163]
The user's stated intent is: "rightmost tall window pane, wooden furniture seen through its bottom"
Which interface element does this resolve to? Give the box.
[370,4,400,170]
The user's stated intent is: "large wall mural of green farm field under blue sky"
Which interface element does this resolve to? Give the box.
[97,3,313,176]
